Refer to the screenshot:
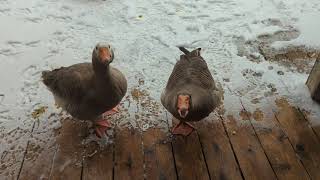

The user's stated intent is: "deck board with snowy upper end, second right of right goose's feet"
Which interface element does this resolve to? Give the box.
[223,94,276,180]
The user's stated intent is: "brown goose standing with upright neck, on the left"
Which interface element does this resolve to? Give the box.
[42,43,127,137]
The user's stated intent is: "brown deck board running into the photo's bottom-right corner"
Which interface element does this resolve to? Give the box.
[276,99,320,179]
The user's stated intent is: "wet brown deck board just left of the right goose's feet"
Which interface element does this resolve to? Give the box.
[143,128,177,180]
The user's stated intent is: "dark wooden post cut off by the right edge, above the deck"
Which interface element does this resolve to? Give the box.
[306,55,320,103]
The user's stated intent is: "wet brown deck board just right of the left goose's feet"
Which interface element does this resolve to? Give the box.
[114,128,144,180]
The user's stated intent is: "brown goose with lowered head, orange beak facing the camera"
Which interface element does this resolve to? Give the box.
[161,47,220,136]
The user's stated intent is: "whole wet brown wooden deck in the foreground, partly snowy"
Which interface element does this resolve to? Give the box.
[0,95,320,180]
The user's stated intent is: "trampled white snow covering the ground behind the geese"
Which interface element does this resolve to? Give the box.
[0,0,320,146]
